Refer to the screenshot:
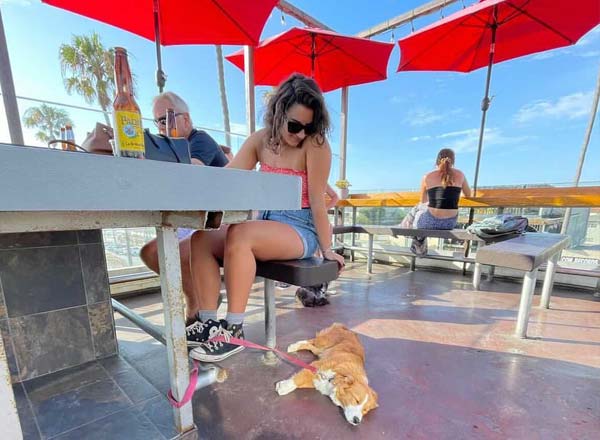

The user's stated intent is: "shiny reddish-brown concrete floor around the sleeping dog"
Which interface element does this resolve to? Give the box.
[115,264,600,440]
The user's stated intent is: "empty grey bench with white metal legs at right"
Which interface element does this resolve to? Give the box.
[473,233,569,338]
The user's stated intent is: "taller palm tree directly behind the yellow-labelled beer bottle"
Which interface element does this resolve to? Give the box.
[59,32,115,125]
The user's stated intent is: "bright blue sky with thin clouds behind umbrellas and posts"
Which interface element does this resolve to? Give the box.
[0,0,600,191]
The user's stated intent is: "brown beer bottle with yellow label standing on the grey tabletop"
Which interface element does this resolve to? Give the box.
[113,47,145,159]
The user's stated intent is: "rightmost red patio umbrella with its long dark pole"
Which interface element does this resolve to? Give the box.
[398,0,600,194]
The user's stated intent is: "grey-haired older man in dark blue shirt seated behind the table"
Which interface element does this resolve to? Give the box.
[140,92,228,325]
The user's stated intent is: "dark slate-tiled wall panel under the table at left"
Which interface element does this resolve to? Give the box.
[0,230,117,382]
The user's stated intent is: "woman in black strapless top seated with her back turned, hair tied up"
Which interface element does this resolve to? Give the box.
[402,148,471,256]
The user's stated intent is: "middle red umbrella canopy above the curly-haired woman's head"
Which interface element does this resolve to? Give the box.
[225,27,394,92]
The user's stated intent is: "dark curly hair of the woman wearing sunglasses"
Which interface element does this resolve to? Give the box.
[264,73,330,151]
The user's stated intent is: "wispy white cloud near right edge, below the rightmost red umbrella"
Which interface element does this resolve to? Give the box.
[515,91,592,123]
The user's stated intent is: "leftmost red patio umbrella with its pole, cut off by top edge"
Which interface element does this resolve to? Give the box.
[42,0,278,92]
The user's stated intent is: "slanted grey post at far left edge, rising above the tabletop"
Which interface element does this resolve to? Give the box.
[0,7,24,145]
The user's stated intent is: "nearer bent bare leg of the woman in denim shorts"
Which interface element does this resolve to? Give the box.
[224,220,304,313]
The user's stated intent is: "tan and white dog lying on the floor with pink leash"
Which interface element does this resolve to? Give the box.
[275,323,378,425]
